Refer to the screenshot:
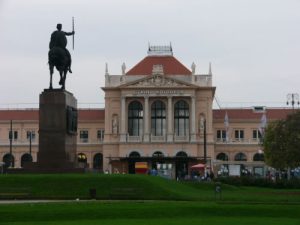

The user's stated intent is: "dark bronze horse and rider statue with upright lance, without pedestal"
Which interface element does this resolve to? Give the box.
[48,19,75,90]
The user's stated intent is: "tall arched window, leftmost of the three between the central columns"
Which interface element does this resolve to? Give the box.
[128,101,143,136]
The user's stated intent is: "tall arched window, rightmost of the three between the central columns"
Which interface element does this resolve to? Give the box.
[174,100,190,136]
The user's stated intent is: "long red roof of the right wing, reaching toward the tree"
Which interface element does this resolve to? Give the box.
[213,108,293,122]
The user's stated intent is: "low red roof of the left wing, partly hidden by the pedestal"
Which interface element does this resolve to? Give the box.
[0,109,105,120]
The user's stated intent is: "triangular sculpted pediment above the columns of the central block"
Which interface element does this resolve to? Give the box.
[120,74,196,88]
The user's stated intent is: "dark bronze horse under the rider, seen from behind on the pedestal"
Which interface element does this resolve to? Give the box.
[48,47,70,90]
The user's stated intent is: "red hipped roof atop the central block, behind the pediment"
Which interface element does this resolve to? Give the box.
[126,56,192,75]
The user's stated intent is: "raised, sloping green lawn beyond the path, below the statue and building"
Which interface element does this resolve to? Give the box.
[0,174,300,204]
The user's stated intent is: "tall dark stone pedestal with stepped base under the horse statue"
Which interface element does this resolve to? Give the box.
[25,89,82,173]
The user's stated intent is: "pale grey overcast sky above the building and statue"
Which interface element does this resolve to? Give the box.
[0,0,300,108]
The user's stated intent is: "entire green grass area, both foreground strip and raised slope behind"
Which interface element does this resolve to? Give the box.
[0,174,300,225]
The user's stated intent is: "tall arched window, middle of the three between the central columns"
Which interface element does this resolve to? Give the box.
[151,101,166,136]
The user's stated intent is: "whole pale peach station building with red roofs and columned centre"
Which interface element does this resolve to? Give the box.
[0,46,290,178]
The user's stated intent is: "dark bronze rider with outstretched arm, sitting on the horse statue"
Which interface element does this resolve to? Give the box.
[49,23,75,73]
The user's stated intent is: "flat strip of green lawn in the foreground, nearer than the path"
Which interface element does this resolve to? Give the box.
[0,201,300,225]
